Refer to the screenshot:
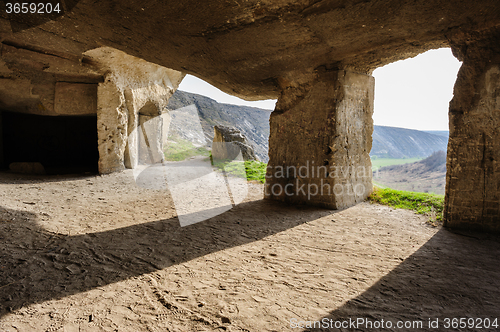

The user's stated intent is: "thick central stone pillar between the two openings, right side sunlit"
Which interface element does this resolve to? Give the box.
[265,70,374,209]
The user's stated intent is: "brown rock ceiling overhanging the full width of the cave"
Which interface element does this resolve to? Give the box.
[0,0,500,100]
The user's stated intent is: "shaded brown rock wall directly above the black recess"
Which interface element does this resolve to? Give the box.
[0,43,103,116]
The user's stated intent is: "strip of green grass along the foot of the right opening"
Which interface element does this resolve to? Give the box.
[368,187,444,225]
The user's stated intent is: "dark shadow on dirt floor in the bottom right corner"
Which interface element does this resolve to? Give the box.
[305,229,500,331]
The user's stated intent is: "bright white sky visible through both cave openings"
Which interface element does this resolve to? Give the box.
[179,49,461,130]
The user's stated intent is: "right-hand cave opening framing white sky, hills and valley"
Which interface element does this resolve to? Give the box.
[370,48,461,195]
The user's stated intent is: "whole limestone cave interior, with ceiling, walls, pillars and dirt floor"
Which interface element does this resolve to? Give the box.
[0,0,500,332]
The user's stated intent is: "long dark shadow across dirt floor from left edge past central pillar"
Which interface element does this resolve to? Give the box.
[0,200,333,317]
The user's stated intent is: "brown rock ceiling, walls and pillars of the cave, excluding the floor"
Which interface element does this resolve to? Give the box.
[0,0,500,231]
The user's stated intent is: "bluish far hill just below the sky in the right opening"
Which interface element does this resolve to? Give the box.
[370,126,448,158]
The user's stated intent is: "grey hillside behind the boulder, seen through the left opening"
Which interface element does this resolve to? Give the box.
[167,90,271,162]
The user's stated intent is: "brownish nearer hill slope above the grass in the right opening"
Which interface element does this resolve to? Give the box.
[373,151,446,195]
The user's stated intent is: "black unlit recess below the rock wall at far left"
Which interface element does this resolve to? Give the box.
[0,111,99,174]
